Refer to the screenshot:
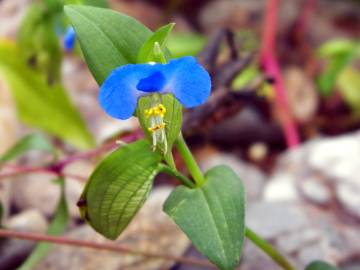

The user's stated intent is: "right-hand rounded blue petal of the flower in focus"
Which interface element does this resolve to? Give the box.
[162,56,211,108]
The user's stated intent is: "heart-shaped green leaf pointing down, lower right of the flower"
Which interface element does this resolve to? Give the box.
[164,166,245,270]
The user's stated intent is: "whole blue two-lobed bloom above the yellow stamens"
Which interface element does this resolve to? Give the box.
[99,56,211,119]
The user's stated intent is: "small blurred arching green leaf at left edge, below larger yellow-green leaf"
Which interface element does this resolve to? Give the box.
[0,133,55,162]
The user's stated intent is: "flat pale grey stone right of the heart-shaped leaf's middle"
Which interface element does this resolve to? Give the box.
[246,201,310,239]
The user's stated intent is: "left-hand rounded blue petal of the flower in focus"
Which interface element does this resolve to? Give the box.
[99,64,159,120]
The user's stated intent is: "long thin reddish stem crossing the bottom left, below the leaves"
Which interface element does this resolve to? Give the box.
[0,229,214,268]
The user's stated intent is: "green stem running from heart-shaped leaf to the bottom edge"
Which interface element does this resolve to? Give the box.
[245,228,295,270]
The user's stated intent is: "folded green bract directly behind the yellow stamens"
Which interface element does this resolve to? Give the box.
[136,94,182,157]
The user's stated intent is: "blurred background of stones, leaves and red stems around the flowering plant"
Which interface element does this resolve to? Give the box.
[0,0,360,270]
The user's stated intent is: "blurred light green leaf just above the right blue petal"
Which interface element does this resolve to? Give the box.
[166,33,207,58]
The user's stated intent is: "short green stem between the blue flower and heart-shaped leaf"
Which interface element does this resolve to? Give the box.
[175,133,205,187]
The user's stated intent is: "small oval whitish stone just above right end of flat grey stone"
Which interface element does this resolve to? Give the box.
[300,178,331,205]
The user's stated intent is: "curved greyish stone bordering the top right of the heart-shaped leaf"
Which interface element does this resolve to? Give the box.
[197,147,265,201]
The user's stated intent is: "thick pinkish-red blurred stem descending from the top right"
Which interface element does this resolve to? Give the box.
[260,0,300,148]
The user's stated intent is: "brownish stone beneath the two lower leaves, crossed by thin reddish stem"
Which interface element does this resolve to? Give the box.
[36,187,190,270]
